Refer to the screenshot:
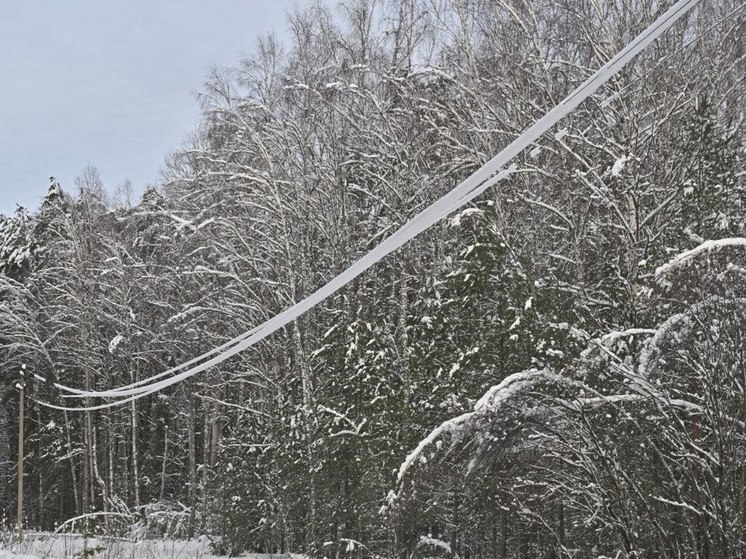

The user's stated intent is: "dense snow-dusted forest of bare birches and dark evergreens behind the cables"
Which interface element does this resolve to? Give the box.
[0,0,746,559]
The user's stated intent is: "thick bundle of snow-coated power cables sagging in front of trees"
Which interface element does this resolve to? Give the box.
[40,0,699,411]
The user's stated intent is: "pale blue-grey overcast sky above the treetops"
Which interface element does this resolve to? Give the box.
[0,0,308,214]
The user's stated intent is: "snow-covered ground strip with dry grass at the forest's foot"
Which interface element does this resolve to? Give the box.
[0,533,303,559]
